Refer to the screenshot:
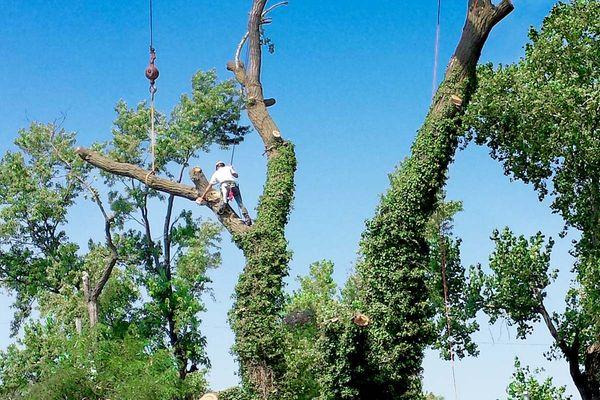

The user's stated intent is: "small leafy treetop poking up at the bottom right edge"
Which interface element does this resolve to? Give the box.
[506,358,571,400]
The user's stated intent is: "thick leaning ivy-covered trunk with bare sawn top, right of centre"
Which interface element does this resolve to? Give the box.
[322,0,513,399]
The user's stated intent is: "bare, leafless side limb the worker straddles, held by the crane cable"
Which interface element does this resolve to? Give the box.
[77,147,250,235]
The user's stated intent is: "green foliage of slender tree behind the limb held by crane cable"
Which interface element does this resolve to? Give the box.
[96,71,237,377]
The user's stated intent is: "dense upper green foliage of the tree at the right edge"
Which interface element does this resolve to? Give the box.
[466,0,600,312]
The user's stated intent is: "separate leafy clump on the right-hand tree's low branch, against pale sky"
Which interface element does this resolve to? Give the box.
[484,228,557,338]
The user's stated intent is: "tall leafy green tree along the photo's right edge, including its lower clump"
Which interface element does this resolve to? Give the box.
[466,0,600,399]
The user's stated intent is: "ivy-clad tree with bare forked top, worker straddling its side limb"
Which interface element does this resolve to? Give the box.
[78,0,296,399]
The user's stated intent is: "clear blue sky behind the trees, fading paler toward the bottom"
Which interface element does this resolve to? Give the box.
[0,0,577,400]
